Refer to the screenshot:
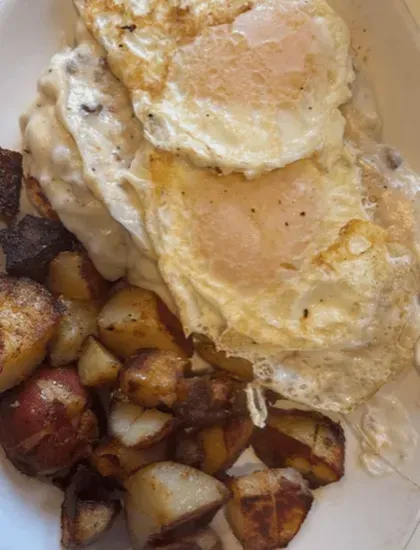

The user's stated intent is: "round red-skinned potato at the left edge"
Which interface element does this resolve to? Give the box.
[0,366,99,476]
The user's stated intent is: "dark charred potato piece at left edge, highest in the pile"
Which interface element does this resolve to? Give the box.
[0,147,23,223]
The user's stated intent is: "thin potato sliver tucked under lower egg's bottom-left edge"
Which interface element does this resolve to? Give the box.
[193,334,254,382]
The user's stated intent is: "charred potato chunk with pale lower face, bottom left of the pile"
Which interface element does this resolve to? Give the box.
[61,466,121,549]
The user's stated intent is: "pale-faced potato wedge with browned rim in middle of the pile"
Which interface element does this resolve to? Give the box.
[109,401,177,449]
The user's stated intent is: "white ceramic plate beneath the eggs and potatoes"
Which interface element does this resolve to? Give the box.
[0,0,420,550]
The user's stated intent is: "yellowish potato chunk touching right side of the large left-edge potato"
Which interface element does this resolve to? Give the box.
[50,296,99,367]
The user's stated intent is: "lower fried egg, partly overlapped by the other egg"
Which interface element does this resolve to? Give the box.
[130,148,418,412]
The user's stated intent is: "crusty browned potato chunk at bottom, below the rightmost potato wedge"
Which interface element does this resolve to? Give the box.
[226,469,313,550]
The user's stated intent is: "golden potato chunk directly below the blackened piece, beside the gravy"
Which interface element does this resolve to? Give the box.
[47,250,108,301]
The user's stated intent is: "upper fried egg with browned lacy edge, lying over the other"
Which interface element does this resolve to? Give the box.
[75,0,353,177]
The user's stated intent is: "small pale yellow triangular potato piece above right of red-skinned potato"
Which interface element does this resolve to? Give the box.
[77,336,122,387]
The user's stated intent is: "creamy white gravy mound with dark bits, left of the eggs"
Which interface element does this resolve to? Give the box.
[21,18,168,296]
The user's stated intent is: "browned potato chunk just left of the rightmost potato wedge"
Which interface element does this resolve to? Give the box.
[175,417,254,476]
